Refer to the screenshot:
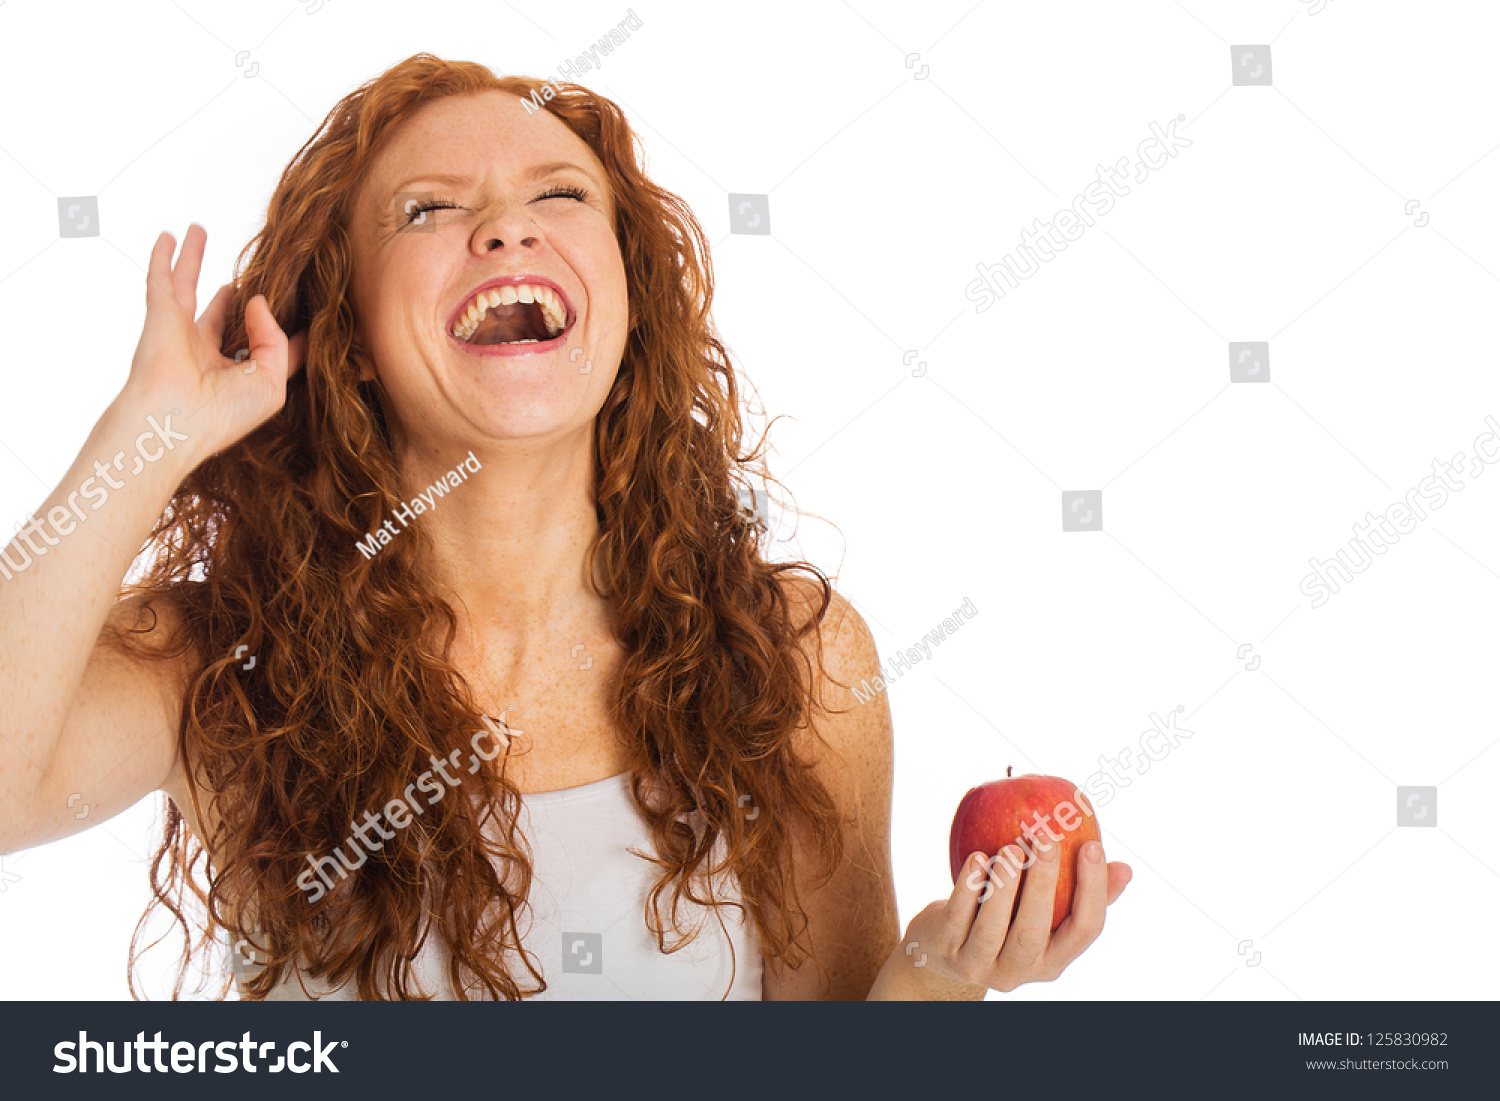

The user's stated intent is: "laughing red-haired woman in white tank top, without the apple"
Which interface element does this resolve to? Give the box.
[0,54,1128,999]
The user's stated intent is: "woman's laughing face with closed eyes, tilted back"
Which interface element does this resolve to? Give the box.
[350,92,629,461]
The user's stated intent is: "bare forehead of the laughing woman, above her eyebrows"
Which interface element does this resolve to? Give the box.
[356,92,609,221]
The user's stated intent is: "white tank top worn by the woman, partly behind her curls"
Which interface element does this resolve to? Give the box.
[225,773,762,1002]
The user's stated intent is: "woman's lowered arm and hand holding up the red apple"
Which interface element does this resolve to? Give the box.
[761,584,1131,1002]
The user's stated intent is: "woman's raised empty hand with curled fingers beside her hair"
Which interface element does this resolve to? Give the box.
[125,224,308,461]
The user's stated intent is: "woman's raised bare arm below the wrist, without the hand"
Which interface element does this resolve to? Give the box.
[0,401,196,852]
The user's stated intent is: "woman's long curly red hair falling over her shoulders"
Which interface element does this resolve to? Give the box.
[111,54,843,1001]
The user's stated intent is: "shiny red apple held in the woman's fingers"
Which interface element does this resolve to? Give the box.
[948,768,1101,929]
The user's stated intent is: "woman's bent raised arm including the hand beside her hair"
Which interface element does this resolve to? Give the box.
[0,225,306,852]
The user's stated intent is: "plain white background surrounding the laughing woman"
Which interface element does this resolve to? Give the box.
[0,0,1500,1001]
